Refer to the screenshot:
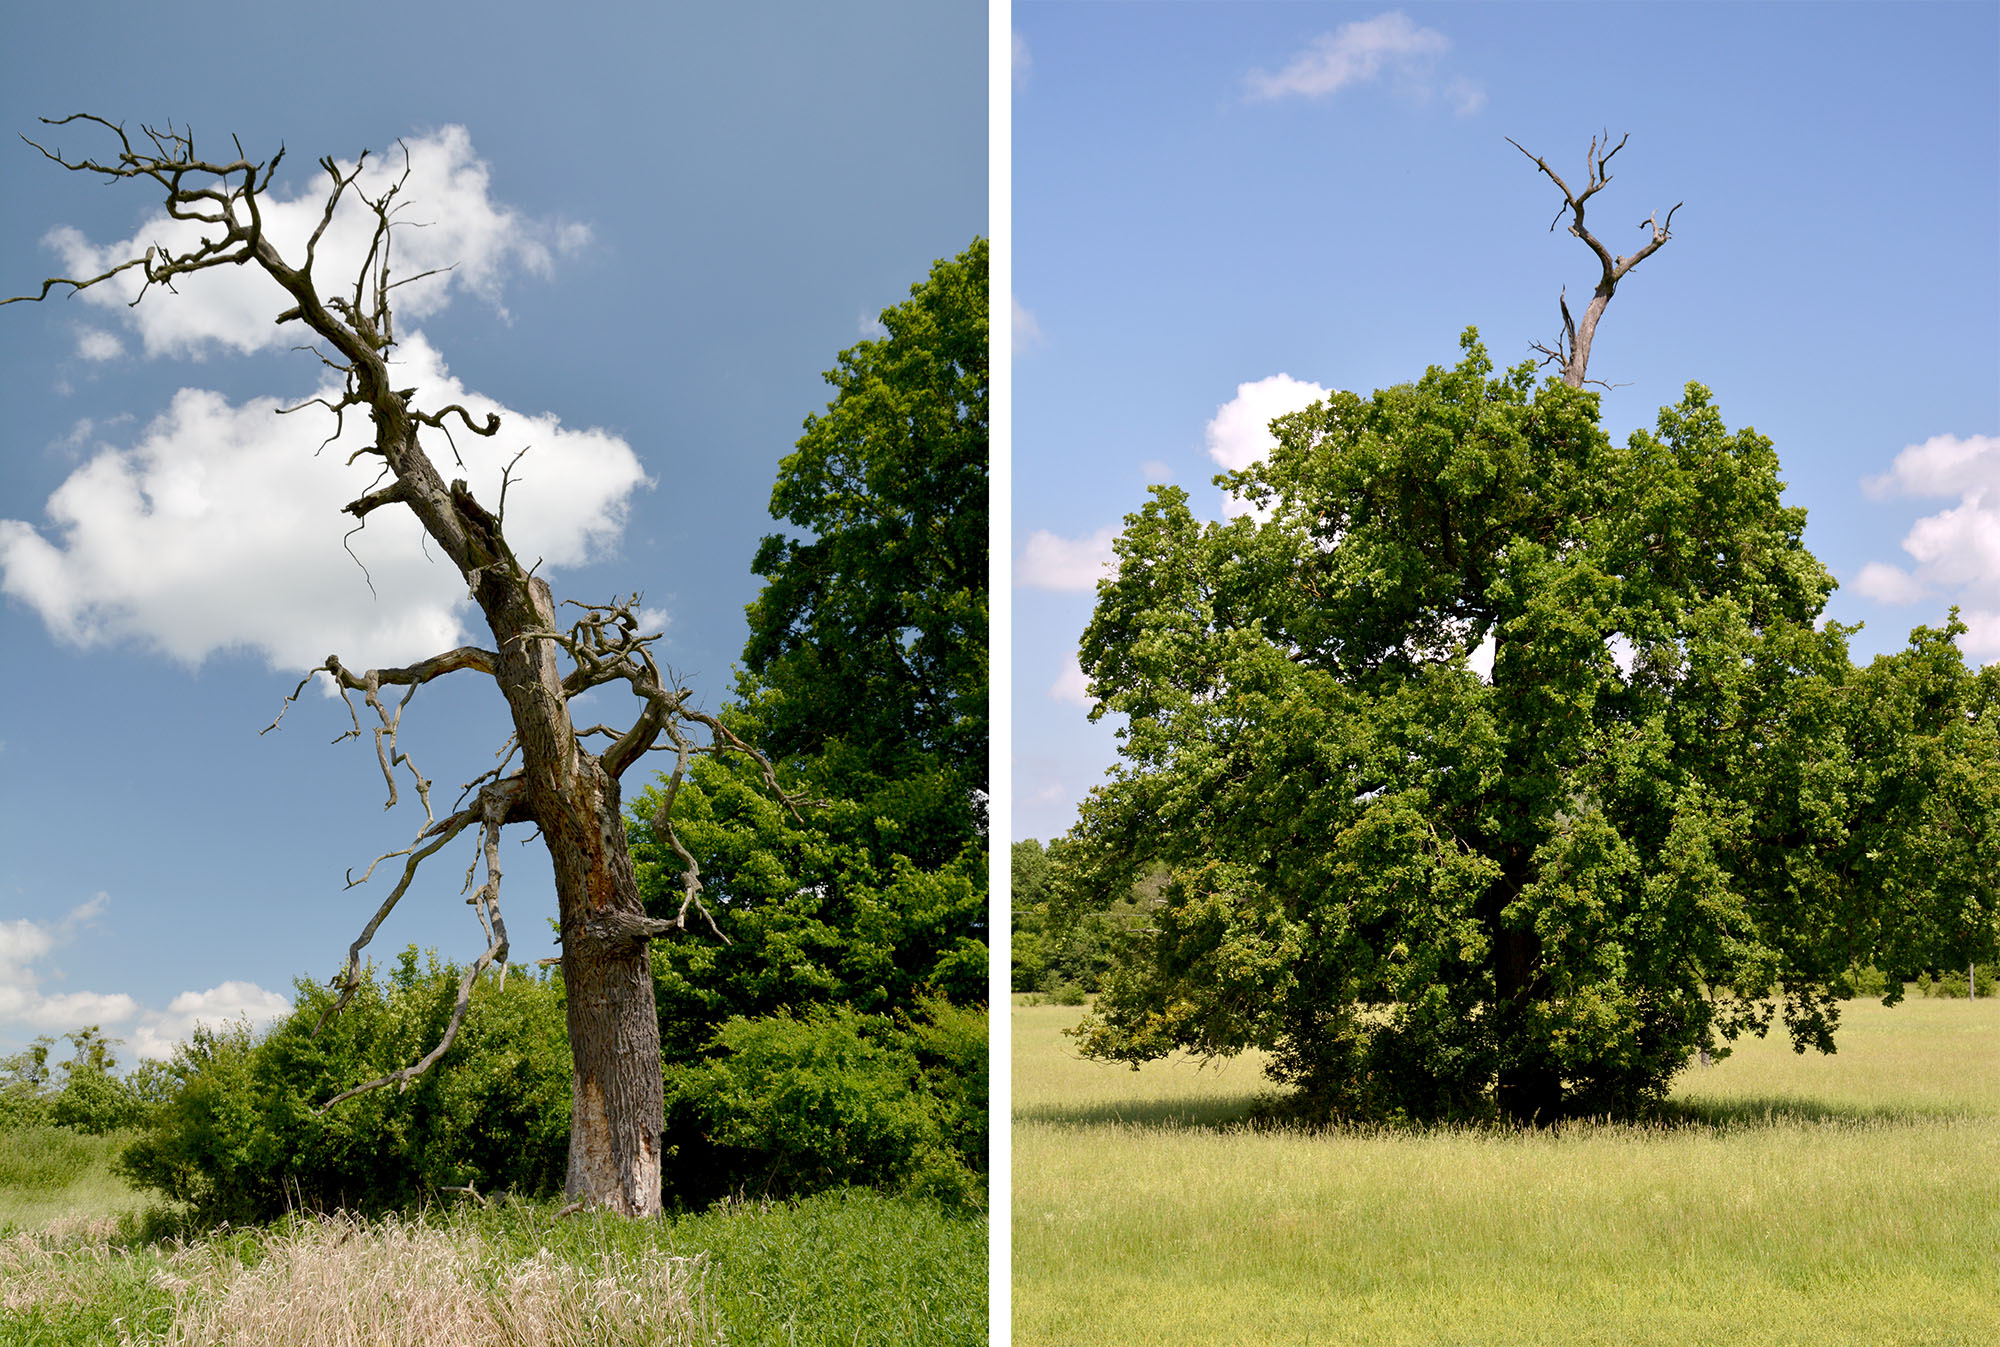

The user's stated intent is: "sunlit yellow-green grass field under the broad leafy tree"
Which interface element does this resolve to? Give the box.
[1014,999,2000,1347]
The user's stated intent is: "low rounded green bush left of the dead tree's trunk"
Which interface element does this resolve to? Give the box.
[122,947,570,1223]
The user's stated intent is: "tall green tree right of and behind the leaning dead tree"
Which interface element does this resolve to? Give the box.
[630,240,988,1181]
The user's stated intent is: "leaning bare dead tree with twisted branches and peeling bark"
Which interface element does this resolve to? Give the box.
[4,114,792,1215]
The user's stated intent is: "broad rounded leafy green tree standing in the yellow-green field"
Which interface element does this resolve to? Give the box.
[1058,332,1994,1119]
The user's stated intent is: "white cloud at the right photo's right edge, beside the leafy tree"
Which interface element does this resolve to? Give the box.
[1852,436,2000,660]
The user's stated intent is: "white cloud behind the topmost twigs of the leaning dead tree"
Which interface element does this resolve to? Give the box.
[42,126,590,356]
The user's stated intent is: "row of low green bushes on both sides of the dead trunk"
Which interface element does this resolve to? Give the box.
[94,949,986,1223]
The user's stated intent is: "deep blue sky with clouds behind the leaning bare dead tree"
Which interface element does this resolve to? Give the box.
[0,0,988,1055]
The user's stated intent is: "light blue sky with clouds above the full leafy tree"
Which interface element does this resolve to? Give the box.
[1012,0,2000,837]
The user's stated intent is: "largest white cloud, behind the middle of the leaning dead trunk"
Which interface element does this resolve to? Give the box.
[0,333,644,670]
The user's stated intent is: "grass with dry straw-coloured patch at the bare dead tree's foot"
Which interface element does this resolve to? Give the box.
[0,1127,986,1347]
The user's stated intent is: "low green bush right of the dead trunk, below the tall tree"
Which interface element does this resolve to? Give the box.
[668,1003,986,1207]
